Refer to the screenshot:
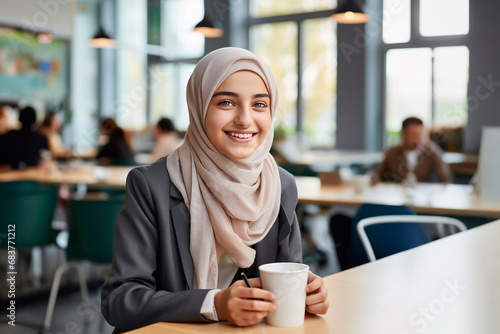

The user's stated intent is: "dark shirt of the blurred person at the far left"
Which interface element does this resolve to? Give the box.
[0,129,49,169]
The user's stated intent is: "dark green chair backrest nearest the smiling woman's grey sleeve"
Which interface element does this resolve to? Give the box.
[66,198,123,263]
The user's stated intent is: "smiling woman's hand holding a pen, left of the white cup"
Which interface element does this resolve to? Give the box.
[214,278,276,326]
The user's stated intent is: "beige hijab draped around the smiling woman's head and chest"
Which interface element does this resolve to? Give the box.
[167,47,281,289]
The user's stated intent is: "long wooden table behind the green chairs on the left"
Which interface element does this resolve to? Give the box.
[0,165,132,189]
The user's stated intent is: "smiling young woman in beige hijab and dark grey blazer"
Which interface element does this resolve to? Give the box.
[101,48,328,332]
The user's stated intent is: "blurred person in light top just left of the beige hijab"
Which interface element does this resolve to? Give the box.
[151,117,181,162]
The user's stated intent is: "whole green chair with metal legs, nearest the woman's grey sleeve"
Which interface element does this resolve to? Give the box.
[44,197,123,331]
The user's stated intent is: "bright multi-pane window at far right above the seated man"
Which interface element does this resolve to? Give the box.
[383,0,469,146]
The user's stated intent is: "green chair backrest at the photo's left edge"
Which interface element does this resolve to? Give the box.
[0,181,58,248]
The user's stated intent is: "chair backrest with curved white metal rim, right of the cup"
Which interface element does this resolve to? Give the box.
[356,215,467,261]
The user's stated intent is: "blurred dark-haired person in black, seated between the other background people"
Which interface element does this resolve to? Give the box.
[96,118,134,165]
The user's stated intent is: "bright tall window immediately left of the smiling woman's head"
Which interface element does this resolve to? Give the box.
[148,0,205,131]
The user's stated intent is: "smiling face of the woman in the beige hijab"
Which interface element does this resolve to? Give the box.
[205,71,272,159]
